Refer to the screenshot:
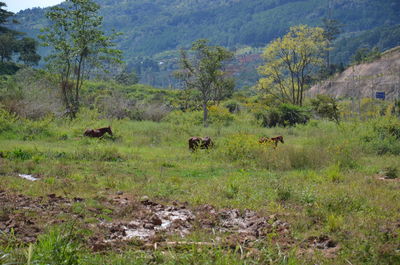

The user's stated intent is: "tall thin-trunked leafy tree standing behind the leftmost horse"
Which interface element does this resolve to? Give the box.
[41,0,121,118]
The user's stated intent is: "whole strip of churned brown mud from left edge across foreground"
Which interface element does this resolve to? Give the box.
[0,190,338,253]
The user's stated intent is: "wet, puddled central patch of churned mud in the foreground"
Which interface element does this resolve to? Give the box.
[92,195,290,250]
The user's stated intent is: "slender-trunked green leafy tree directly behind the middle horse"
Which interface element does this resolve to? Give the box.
[175,39,234,127]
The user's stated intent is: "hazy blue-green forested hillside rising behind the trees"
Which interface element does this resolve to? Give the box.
[10,0,400,86]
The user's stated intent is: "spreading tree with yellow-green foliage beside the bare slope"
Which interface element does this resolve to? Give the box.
[258,25,326,106]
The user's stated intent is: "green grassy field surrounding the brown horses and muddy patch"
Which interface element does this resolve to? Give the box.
[0,109,400,264]
